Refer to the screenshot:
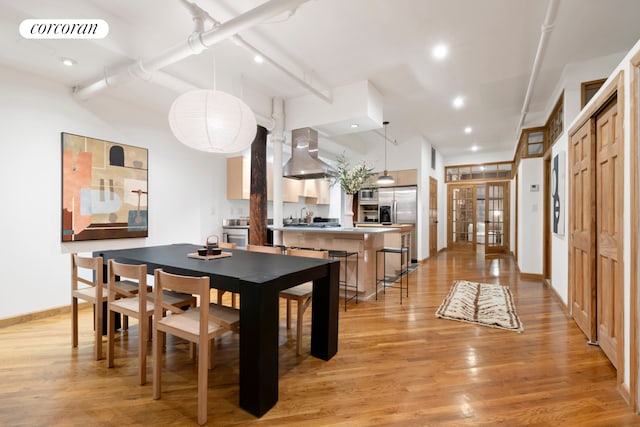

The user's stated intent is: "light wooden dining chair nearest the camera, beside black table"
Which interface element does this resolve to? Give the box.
[153,269,228,425]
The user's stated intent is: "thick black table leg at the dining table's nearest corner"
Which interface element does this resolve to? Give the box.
[240,283,279,417]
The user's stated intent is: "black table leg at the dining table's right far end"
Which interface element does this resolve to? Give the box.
[311,261,340,360]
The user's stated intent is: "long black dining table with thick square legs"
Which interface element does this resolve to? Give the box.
[93,243,340,417]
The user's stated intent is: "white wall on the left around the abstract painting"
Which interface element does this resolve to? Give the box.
[0,67,227,318]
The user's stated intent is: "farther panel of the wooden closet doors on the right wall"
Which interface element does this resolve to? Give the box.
[568,120,596,342]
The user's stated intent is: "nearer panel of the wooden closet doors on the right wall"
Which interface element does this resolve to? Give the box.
[596,100,624,367]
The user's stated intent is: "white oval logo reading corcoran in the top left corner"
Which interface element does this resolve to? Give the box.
[20,19,109,39]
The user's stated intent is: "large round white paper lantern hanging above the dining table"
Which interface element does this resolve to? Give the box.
[169,89,257,153]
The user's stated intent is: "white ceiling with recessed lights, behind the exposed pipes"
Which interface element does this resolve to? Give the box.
[0,0,640,157]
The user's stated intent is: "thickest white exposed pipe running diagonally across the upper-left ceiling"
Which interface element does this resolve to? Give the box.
[74,0,309,100]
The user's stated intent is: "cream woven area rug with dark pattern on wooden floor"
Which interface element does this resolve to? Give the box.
[436,280,524,332]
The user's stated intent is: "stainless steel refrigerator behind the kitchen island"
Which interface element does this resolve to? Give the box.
[378,186,418,258]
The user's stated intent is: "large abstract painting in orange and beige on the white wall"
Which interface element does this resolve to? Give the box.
[61,132,148,242]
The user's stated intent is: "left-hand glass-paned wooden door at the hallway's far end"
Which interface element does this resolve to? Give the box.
[447,184,476,251]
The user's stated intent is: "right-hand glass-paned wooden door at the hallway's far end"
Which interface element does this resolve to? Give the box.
[484,182,509,255]
